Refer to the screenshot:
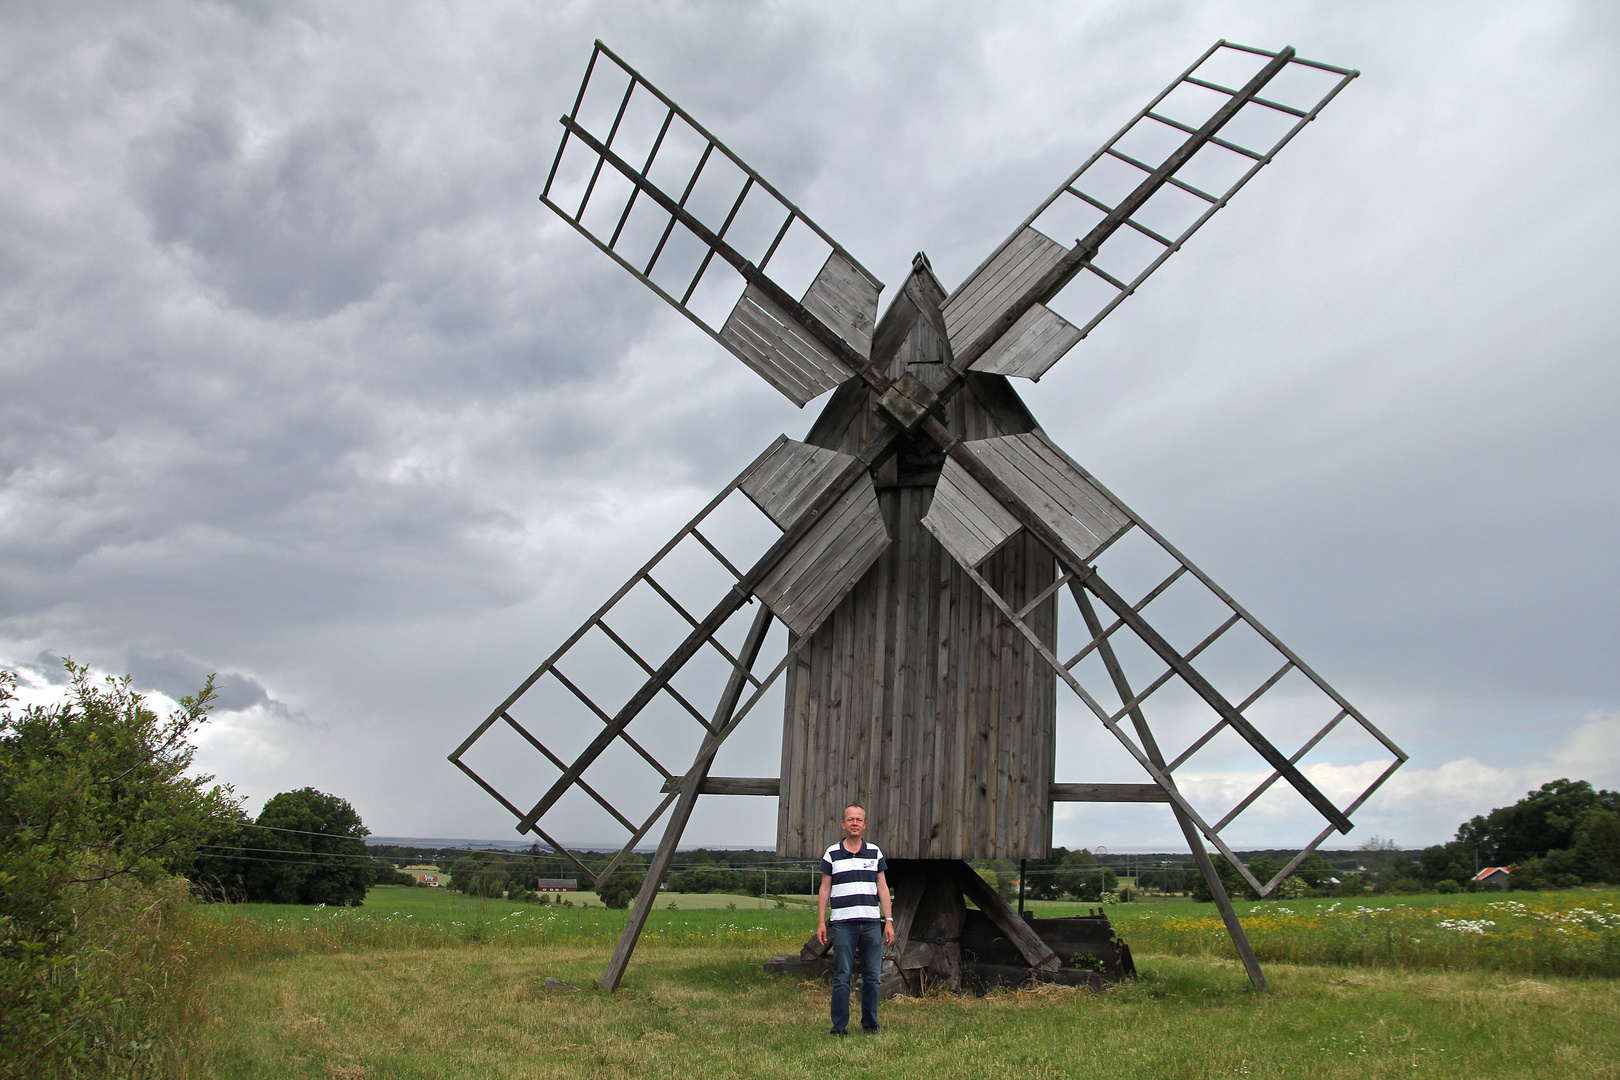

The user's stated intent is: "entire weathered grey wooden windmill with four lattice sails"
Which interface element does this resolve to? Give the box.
[450,40,1406,989]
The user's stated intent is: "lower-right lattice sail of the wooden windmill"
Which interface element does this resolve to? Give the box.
[923,432,1406,895]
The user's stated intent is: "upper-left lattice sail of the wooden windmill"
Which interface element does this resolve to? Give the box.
[539,42,883,406]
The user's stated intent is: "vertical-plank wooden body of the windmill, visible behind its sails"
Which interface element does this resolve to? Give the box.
[773,257,1056,858]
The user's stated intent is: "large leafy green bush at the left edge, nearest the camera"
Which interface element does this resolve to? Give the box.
[0,661,240,1077]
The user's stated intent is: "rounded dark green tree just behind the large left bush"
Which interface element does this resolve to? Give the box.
[199,787,376,907]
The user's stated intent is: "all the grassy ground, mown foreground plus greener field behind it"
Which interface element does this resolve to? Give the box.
[167,889,1620,1080]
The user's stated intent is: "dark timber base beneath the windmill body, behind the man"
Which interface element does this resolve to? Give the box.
[765,860,1136,997]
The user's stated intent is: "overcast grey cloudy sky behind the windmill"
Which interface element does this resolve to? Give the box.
[0,0,1620,850]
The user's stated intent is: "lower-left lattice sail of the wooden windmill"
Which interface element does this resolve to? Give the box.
[450,436,889,878]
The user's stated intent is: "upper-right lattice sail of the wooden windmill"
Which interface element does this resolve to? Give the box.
[944,40,1358,379]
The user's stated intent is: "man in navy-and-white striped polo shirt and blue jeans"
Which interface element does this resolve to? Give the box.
[815,806,894,1035]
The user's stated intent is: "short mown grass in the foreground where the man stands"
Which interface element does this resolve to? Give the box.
[177,944,1620,1080]
